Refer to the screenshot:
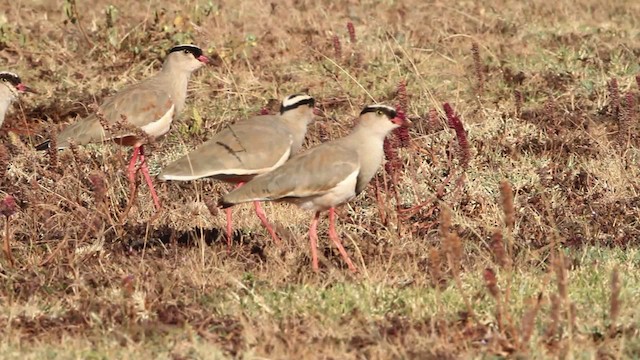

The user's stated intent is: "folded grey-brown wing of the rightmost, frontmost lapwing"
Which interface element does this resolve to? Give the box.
[222,143,360,204]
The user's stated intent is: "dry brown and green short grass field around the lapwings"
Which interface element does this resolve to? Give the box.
[0,0,640,359]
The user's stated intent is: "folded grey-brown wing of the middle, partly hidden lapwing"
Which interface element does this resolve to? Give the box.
[160,118,292,180]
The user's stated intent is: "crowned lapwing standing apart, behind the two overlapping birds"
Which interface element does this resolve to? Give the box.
[36,45,209,209]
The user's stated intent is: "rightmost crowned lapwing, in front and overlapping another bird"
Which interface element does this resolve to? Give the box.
[219,105,411,272]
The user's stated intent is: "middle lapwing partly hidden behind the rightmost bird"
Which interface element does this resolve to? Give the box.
[158,94,315,247]
